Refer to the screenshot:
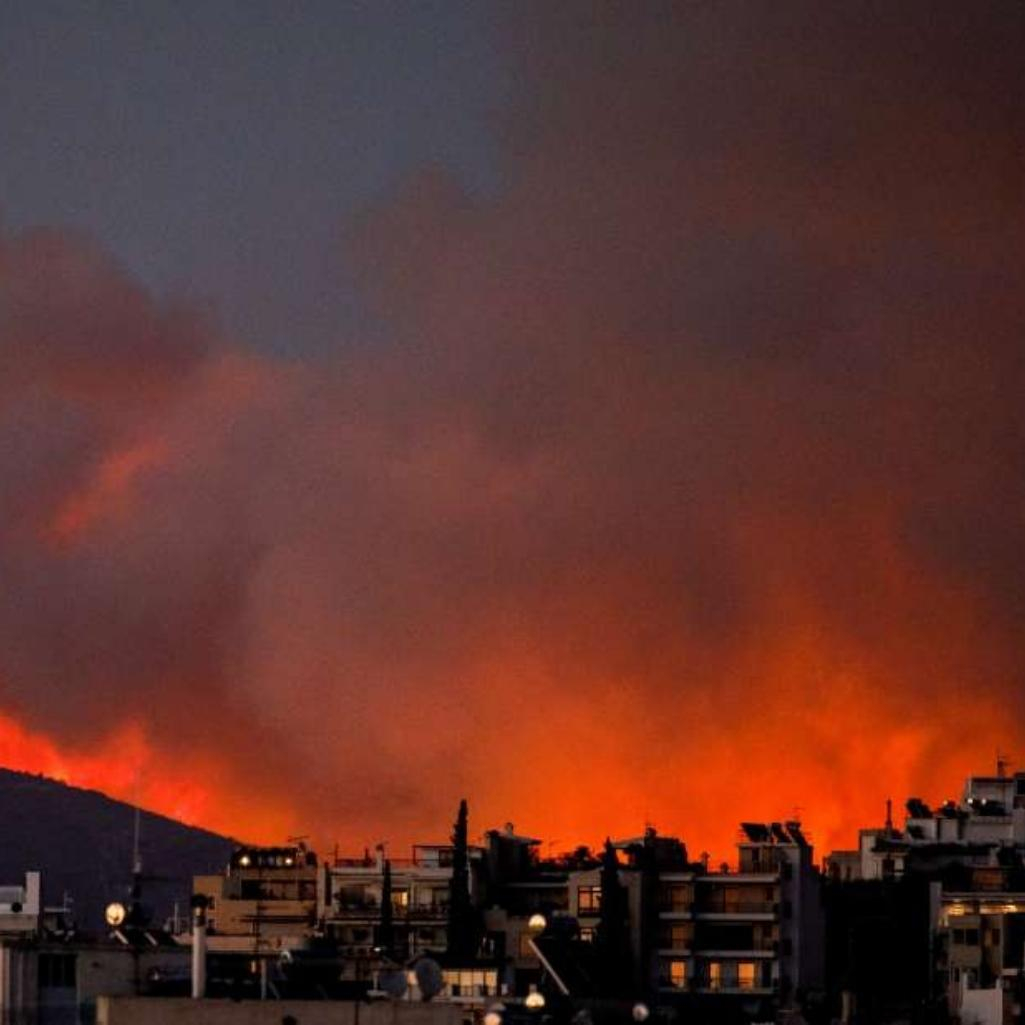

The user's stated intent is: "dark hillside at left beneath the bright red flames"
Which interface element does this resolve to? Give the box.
[0,769,234,932]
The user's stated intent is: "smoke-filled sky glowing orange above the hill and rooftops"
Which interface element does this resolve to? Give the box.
[0,0,1025,858]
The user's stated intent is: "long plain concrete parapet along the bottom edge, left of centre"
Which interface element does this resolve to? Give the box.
[96,996,469,1025]
